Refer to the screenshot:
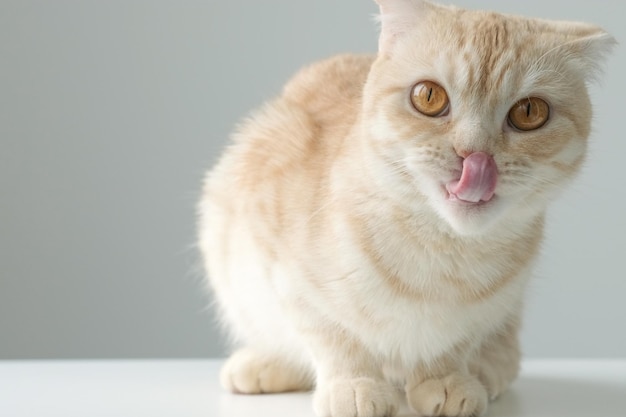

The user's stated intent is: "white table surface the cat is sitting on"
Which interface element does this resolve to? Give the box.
[0,359,626,417]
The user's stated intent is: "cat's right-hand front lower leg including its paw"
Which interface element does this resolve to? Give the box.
[405,351,488,417]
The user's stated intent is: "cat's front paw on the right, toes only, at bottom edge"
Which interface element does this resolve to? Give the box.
[406,374,488,417]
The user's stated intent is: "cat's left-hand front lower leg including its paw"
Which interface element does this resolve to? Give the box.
[313,334,399,417]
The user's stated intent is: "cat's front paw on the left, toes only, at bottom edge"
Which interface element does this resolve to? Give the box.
[313,378,398,417]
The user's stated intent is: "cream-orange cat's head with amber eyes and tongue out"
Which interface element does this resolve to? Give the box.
[361,0,615,234]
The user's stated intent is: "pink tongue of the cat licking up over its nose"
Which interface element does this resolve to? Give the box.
[446,152,498,203]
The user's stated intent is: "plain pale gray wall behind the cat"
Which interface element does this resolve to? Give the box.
[0,0,626,359]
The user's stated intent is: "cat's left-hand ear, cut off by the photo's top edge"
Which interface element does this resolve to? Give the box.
[376,0,433,54]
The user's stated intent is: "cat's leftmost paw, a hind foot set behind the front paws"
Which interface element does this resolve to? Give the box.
[220,349,312,394]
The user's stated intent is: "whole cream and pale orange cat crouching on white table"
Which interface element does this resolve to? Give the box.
[198,0,615,417]
